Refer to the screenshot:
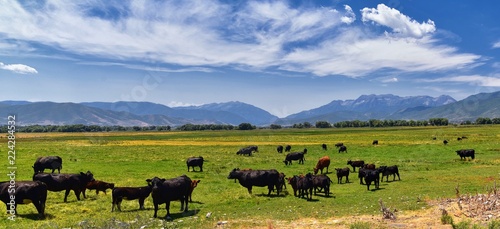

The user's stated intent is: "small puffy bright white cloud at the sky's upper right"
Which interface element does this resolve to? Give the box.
[361,4,436,38]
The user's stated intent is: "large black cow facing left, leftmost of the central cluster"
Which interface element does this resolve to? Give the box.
[227,169,281,196]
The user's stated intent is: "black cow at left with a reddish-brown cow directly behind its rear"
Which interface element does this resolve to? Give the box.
[33,171,95,202]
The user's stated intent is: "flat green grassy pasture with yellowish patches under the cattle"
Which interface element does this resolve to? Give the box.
[0,125,500,228]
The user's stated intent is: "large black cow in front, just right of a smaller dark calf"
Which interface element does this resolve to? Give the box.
[146,175,192,219]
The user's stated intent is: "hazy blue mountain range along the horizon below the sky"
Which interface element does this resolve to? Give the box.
[0,91,500,126]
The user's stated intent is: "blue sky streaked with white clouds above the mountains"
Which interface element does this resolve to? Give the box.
[0,0,500,117]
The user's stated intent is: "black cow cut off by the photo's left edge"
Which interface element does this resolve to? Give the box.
[0,181,47,219]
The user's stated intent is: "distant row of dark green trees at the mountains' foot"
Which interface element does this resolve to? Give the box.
[0,117,500,133]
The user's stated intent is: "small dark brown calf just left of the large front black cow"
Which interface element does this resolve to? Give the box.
[111,183,153,212]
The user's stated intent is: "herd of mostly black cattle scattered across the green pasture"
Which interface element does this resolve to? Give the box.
[0,140,475,218]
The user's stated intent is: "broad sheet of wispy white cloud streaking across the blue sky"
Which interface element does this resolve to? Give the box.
[0,0,481,77]
